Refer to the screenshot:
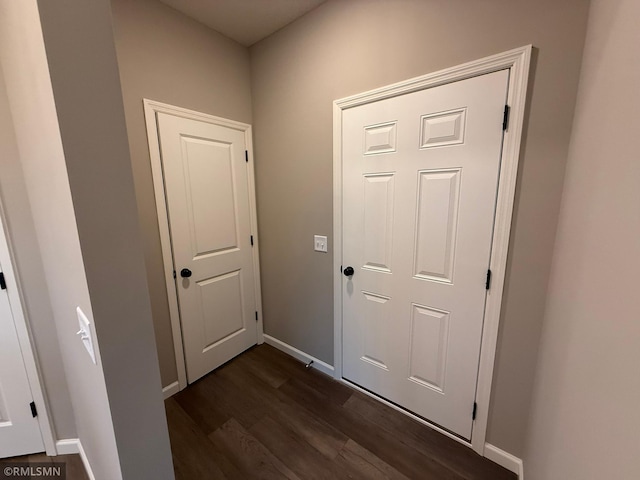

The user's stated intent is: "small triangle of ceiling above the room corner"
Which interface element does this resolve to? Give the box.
[160,0,326,47]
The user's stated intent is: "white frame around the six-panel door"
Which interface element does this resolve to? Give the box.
[333,45,532,455]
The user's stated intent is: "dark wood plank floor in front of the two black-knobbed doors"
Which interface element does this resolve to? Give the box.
[165,345,516,480]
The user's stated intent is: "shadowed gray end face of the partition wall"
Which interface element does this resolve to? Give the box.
[38,0,173,480]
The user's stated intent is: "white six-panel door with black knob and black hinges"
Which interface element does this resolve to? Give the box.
[342,70,508,439]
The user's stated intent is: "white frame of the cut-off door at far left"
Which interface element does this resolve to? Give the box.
[0,204,58,456]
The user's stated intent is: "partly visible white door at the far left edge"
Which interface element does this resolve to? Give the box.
[0,258,44,458]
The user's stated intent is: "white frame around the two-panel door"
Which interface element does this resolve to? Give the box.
[143,98,264,394]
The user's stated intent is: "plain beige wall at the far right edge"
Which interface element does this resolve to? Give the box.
[524,0,640,480]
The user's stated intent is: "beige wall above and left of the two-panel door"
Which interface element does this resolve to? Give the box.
[112,0,252,386]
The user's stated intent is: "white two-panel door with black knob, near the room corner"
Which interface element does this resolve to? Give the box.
[157,113,258,382]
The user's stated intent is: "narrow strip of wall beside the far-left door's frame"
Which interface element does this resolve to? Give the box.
[0,60,78,438]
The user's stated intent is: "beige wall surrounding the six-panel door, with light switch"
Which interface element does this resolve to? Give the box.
[250,0,588,455]
